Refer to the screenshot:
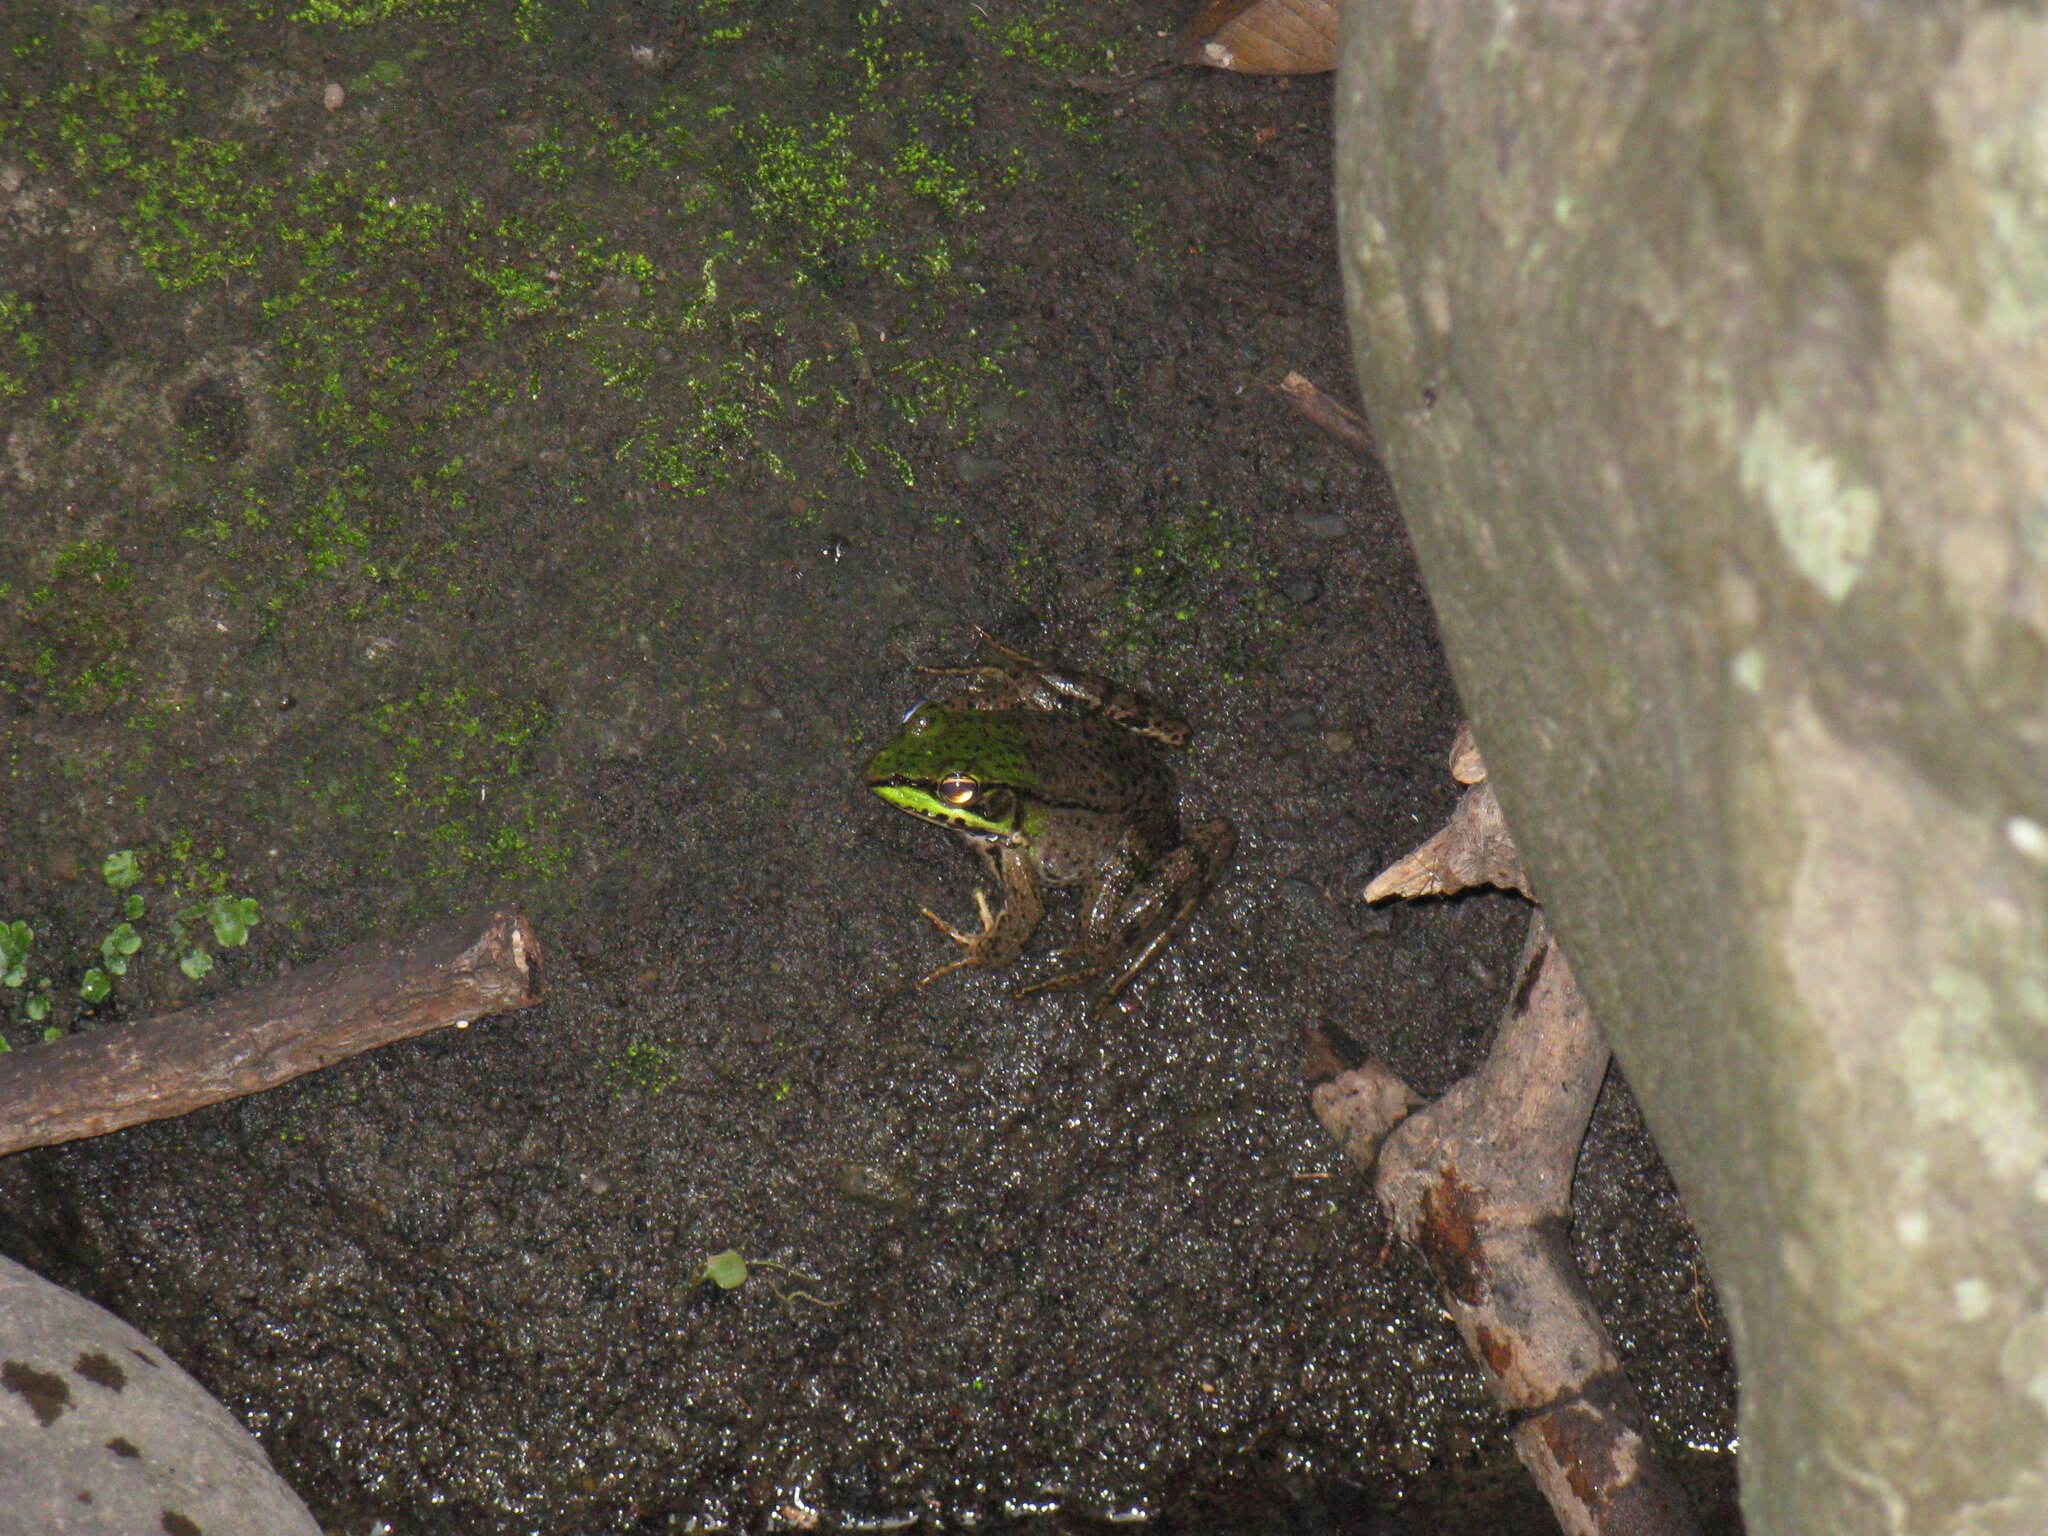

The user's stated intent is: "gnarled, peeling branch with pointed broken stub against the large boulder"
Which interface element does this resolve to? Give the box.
[1311,733,1698,1536]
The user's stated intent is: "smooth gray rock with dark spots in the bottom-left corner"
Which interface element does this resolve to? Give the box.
[0,1260,319,1536]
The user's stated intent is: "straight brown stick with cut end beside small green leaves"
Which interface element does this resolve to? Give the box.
[0,911,543,1155]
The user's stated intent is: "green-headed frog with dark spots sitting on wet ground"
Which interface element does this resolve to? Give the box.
[864,631,1237,1008]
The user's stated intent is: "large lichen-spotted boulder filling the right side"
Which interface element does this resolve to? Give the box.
[1337,0,2048,1536]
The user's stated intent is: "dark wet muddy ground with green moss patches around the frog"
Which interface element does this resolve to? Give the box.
[0,0,1733,1536]
